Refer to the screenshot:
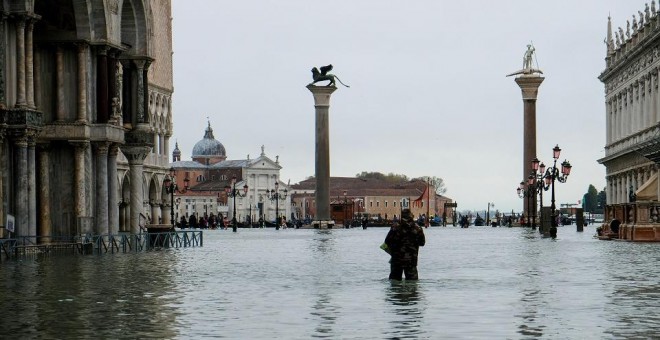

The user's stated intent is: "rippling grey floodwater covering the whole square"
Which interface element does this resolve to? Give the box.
[0,226,660,339]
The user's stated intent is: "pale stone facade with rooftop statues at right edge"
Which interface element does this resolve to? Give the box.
[598,1,660,210]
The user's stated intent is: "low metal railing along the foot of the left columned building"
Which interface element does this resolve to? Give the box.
[0,230,204,260]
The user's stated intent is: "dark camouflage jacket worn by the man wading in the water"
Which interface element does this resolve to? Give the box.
[385,222,426,266]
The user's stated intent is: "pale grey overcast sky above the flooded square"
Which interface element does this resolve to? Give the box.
[171,0,645,211]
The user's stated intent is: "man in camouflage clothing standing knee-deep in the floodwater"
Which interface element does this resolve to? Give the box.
[385,209,426,280]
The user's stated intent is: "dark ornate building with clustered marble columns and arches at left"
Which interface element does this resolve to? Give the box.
[0,0,173,238]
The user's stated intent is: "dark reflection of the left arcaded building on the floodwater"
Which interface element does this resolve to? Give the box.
[0,255,177,338]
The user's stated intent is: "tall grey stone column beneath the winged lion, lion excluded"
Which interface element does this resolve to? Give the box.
[307,84,337,229]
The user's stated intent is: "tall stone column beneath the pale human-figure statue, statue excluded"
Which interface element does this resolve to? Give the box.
[515,74,550,216]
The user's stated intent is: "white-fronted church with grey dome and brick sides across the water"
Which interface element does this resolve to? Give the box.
[170,122,291,224]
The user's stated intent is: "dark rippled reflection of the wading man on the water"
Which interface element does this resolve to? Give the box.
[385,280,425,339]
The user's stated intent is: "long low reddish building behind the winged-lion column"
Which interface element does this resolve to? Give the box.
[291,177,452,224]
